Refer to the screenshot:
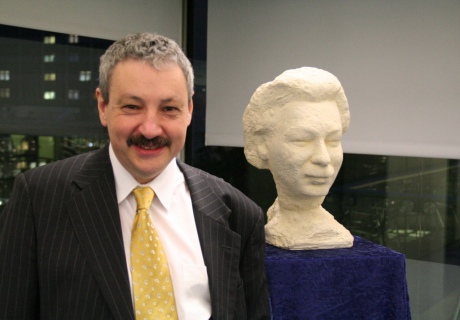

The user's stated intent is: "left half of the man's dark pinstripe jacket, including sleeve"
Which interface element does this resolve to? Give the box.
[0,146,134,320]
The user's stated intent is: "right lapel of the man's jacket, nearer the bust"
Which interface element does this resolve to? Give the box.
[178,162,241,319]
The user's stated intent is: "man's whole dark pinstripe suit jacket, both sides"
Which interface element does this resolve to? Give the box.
[0,147,269,320]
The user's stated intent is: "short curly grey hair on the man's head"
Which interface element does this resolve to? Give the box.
[99,32,194,103]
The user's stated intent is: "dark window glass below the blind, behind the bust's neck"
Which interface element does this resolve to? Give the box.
[191,147,460,320]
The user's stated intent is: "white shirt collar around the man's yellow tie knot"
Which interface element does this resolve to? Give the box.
[109,144,184,211]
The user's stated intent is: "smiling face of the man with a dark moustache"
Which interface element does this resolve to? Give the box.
[96,60,193,183]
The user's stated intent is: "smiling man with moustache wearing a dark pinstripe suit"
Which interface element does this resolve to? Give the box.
[0,33,269,320]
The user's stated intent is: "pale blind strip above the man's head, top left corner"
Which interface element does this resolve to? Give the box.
[0,0,182,43]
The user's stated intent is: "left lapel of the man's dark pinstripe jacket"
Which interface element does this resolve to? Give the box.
[69,147,134,319]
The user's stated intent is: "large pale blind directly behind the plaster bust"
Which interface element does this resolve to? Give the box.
[206,0,460,159]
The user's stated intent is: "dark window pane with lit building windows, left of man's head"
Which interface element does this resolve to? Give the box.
[0,25,112,138]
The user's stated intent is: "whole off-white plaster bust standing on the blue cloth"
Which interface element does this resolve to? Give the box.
[243,67,353,250]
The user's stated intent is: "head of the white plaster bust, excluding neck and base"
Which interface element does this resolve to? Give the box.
[243,67,350,201]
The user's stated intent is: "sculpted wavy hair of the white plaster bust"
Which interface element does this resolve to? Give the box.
[243,67,350,169]
